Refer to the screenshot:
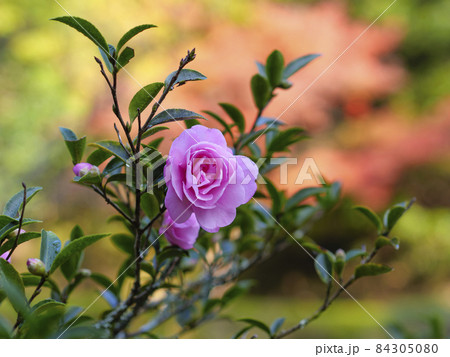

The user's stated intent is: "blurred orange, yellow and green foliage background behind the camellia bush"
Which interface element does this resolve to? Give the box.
[0,0,450,338]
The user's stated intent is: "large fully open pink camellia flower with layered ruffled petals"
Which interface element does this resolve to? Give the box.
[164,125,258,233]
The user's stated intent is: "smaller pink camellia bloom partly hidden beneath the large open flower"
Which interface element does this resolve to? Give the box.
[159,211,200,250]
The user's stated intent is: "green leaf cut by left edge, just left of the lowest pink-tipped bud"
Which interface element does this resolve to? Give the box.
[0,259,28,314]
